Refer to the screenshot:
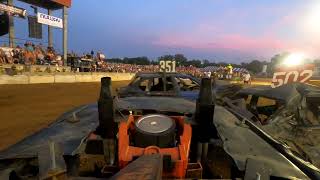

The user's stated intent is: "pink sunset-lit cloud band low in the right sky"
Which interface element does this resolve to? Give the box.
[152,29,320,56]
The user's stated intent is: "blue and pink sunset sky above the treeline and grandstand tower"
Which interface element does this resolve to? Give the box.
[0,0,320,63]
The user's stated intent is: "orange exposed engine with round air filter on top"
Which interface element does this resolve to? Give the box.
[118,114,191,178]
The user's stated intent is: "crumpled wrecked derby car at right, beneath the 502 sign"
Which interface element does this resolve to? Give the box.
[230,83,320,168]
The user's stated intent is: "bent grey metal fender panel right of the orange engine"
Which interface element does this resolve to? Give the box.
[214,106,309,179]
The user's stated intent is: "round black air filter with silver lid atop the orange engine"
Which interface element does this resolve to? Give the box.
[134,114,176,148]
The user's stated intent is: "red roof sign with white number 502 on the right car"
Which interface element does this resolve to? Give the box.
[271,64,315,88]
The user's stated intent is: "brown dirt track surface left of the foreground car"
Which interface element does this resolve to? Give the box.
[0,81,128,150]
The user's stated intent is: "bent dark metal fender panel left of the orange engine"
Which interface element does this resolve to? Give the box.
[0,104,98,159]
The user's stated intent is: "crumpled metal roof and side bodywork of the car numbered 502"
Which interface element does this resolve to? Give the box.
[235,83,320,167]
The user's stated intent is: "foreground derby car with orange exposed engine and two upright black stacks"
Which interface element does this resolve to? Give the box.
[0,78,320,179]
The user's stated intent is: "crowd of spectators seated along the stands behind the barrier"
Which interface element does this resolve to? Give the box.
[0,42,250,77]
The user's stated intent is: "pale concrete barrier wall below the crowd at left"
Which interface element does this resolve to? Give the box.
[0,73,135,84]
